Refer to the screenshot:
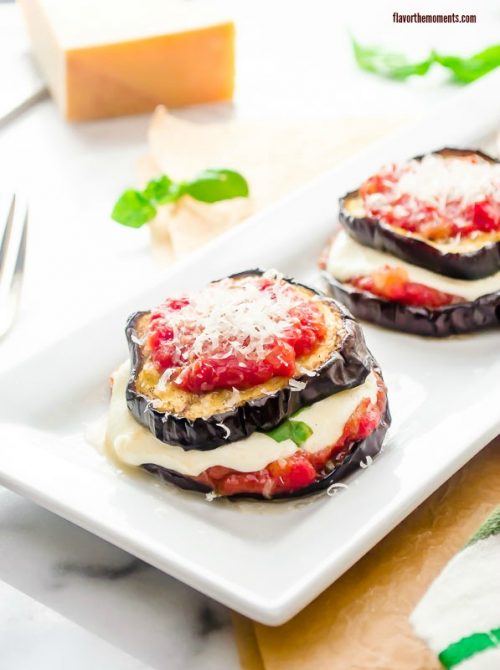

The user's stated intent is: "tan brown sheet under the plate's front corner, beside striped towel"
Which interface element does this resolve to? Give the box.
[234,437,500,670]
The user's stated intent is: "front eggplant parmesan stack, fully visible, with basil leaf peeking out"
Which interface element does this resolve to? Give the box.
[106,270,390,499]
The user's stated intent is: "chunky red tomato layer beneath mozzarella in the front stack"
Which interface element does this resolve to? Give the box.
[195,378,387,498]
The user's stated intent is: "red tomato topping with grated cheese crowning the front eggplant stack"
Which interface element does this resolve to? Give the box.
[148,276,326,393]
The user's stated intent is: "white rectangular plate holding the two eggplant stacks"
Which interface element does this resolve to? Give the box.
[0,72,500,625]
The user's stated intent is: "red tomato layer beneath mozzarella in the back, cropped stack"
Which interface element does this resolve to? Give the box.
[349,265,465,307]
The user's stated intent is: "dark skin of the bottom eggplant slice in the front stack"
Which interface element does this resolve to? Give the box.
[141,392,391,502]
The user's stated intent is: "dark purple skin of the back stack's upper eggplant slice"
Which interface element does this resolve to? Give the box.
[339,148,500,279]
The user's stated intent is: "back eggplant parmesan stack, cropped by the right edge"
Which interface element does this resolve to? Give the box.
[321,149,500,337]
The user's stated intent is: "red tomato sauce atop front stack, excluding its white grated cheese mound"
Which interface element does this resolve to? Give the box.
[148,277,326,393]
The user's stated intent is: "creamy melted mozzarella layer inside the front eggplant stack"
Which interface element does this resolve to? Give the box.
[106,361,377,477]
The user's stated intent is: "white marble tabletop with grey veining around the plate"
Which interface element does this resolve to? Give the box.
[0,0,500,670]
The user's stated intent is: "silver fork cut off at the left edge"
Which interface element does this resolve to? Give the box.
[0,195,28,339]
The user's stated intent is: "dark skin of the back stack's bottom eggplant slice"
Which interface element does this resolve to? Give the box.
[322,271,500,337]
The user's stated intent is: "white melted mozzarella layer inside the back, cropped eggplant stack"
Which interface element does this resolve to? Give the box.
[327,230,500,300]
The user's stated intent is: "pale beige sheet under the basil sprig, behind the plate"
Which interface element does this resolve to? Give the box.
[139,107,401,261]
